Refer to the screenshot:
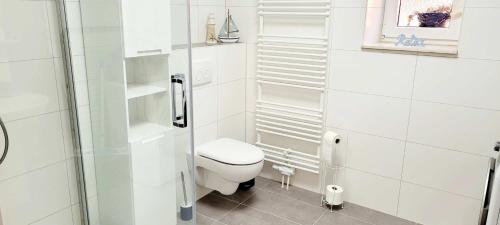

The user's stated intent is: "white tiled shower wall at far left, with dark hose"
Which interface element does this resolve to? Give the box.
[0,1,84,225]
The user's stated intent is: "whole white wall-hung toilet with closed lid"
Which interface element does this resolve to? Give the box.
[194,138,264,195]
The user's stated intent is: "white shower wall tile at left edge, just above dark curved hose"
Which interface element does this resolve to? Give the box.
[0,59,59,121]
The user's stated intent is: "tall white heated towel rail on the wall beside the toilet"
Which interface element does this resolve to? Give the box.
[256,0,330,174]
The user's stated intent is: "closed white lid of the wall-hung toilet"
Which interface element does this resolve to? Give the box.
[196,138,264,165]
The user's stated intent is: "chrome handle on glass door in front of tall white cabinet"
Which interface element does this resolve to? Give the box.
[171,73,187,128]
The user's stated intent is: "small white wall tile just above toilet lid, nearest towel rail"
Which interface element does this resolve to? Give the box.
[217,112,246,141]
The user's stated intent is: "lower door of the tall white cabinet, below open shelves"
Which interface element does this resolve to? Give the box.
[130,130,177,225]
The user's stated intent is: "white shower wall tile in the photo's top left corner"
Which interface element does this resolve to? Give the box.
[0,1,52,62]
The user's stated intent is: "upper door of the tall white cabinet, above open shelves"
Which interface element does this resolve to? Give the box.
[122,0,171,58]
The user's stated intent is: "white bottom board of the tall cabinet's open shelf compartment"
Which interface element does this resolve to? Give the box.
[128,122,172,143]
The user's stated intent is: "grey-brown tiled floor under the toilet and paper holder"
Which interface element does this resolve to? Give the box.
[197,177,416,225]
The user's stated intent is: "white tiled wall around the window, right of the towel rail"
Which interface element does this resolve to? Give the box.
[243,0,500,225]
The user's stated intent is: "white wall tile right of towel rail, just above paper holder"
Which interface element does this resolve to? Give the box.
[327,91,410,140]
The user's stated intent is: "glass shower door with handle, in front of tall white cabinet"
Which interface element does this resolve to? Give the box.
[66,0,195,225]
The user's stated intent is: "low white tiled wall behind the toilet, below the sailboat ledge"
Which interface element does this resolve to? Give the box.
[189,43,246,153]
